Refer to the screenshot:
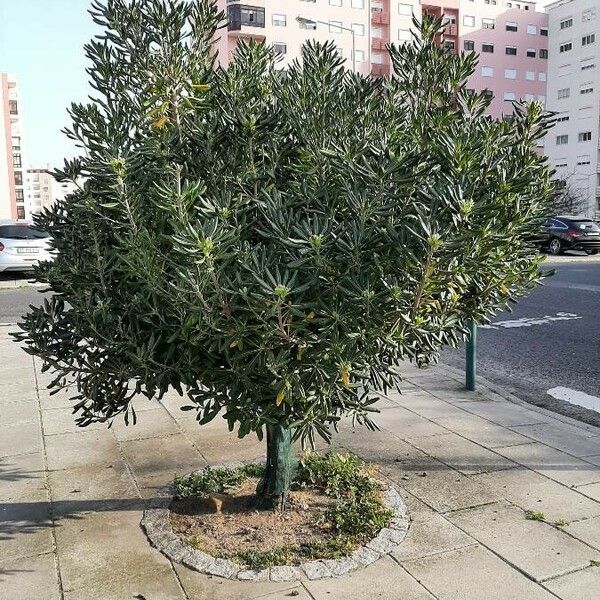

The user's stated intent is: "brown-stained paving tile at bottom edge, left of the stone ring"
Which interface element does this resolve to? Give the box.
[56,510,184,600]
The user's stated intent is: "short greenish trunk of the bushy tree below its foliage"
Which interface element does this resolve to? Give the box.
[256,423,295,510]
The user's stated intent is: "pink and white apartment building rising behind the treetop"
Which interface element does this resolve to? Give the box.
[217,0,548,117]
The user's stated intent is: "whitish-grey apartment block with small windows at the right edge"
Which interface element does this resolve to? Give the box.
[546,0,600,218]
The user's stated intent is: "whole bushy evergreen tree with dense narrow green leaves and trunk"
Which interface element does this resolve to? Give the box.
[16,0,550,506]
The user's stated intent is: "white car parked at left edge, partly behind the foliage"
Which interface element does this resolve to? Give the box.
[0,220,54,273]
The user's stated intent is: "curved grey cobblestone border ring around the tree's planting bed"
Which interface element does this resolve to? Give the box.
[141,465,410,581]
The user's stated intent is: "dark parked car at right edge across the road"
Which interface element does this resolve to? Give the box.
[541,216,600,254]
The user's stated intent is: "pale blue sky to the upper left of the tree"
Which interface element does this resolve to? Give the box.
[0,0,551,167]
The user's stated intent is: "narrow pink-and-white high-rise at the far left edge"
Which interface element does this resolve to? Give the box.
[0,73,31,220]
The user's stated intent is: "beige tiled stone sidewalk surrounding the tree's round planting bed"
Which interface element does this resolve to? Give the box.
[0,328,600,600]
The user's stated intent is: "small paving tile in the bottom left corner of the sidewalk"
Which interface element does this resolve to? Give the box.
[0,552,60,600]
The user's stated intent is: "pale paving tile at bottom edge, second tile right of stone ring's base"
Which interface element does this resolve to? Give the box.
[402,546,556,600]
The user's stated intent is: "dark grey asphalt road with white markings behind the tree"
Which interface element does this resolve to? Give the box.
[0,255,600,426]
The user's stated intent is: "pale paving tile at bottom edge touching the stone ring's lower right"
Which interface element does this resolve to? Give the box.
[304,556,435,600]
